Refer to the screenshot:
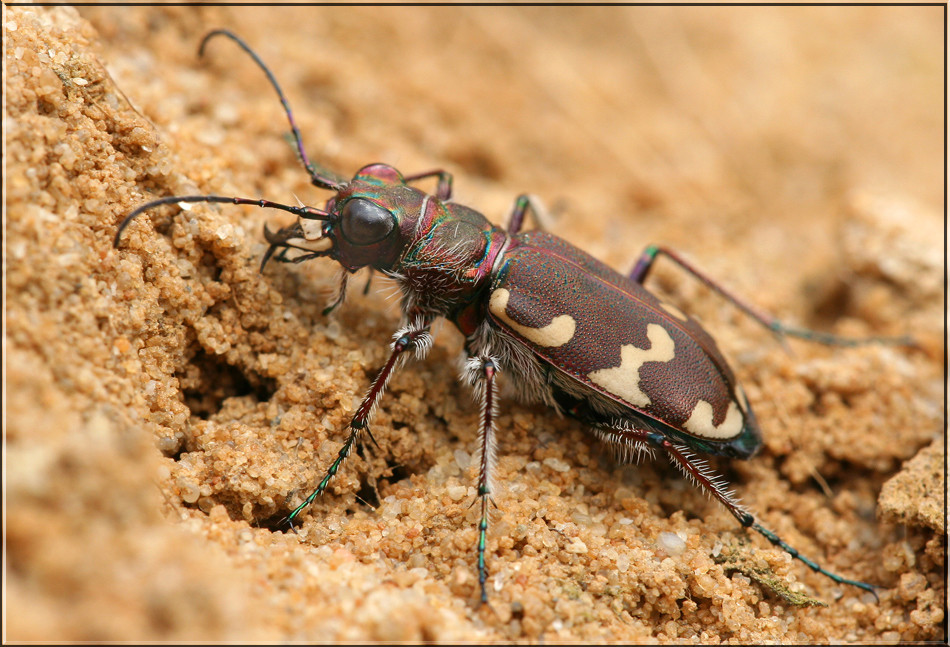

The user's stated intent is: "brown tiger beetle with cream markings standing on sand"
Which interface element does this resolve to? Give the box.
[114,30,912,604]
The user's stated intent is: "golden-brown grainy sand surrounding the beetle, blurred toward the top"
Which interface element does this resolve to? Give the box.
[3,7,946,642]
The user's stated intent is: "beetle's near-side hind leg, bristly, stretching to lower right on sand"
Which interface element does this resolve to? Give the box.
[608,427,877,598]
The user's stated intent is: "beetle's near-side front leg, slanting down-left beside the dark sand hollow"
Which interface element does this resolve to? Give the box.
[286,317,432,529]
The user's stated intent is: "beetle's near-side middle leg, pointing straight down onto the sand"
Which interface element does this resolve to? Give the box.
[463,357,498,604]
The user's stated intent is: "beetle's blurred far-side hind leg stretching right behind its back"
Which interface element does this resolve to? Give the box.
[629,245,916,346]
